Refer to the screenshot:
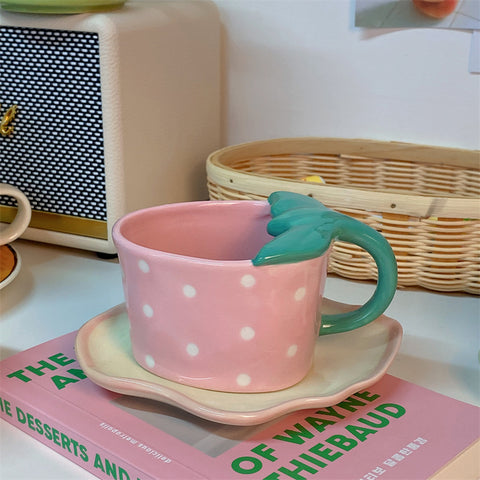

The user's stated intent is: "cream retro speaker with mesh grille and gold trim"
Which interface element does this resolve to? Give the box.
[0,1,220,254]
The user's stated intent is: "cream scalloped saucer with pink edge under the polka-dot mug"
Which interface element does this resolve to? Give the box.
[75,299,402,425]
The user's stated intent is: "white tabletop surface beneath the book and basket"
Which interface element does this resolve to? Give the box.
[0,240,480,480]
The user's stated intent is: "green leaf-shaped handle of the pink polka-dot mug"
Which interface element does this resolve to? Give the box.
[252,192,397,335]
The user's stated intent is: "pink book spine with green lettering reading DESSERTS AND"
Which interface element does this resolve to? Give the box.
[0,391,154,480]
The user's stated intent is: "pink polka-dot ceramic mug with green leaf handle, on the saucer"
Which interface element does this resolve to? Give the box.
[113,192,397,392]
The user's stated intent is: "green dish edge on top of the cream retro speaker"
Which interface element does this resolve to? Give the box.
[0,0,126,14]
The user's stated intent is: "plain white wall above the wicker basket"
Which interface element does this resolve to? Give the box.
[215,0,480,149]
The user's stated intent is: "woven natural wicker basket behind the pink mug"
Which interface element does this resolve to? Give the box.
[207,138,480,294]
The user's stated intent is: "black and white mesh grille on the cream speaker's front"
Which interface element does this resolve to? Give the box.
[0,26,106,220]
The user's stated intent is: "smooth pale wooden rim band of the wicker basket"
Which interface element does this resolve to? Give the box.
[207,137,480,220]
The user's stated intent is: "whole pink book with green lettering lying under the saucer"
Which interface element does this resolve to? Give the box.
[0,332,479,480]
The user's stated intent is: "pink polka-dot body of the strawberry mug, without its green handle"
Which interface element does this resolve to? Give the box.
[113,201,327,392]
